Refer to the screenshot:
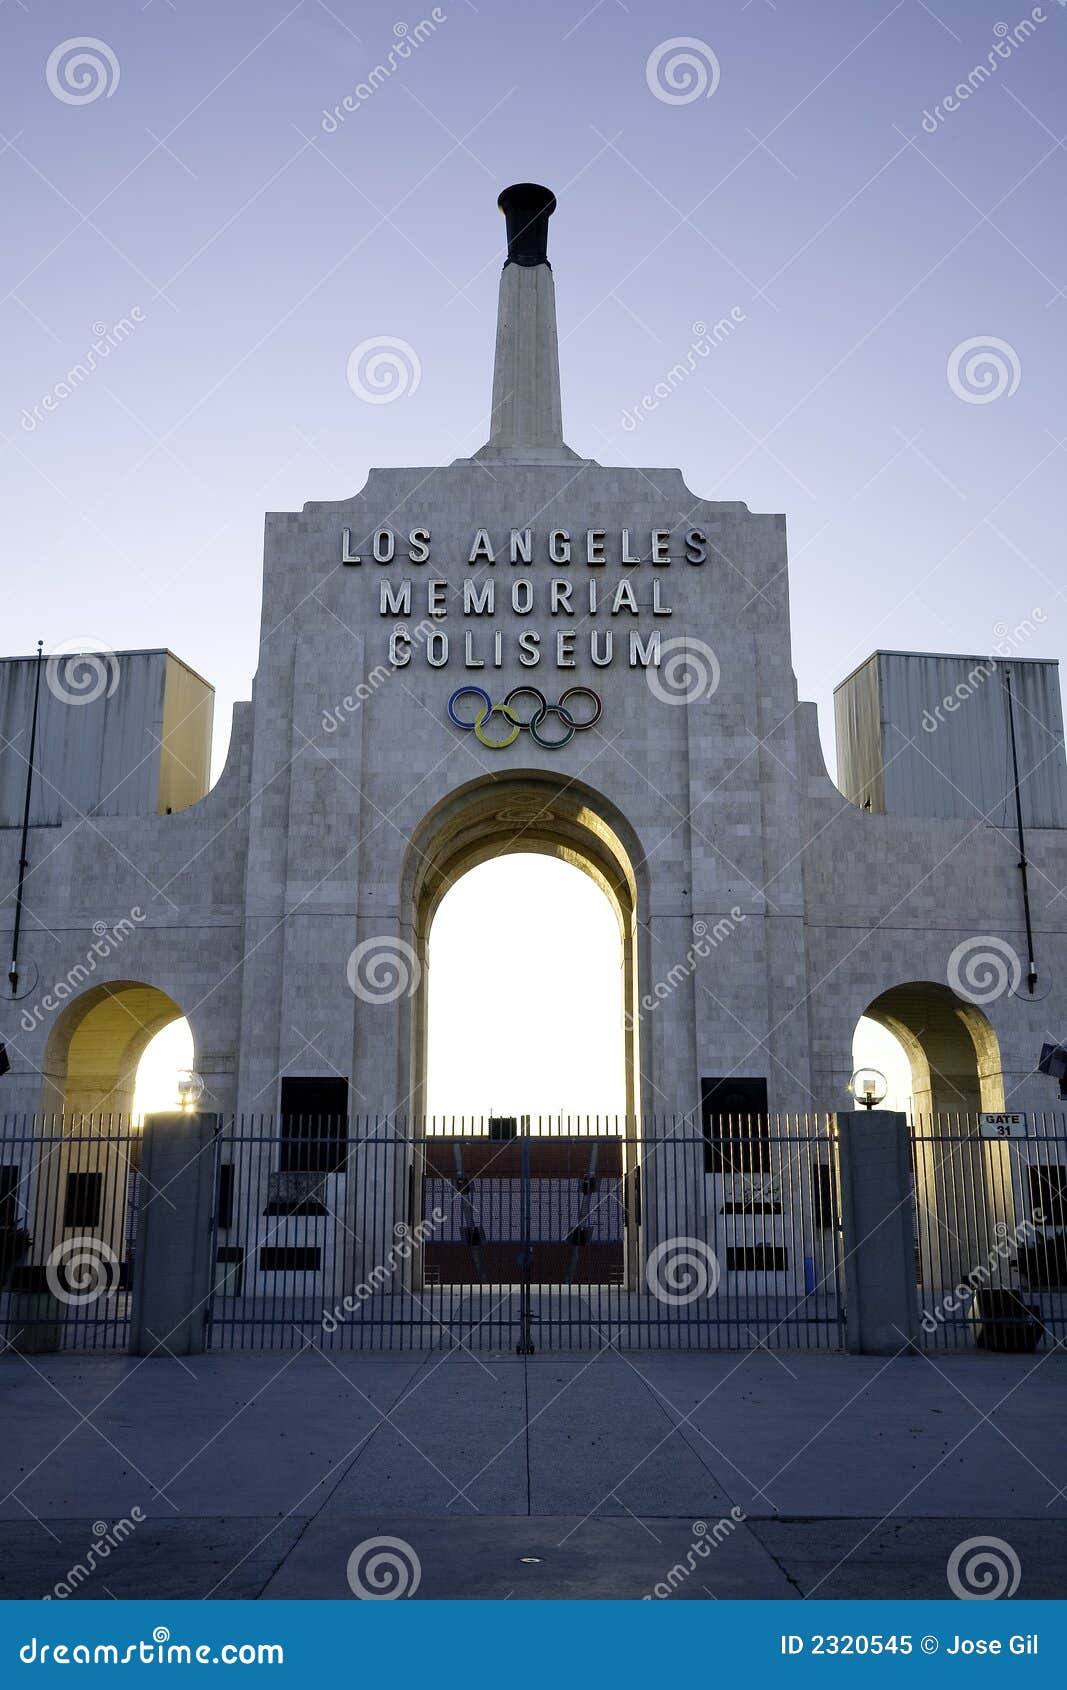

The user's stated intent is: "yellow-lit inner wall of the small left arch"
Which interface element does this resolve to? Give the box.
[41,980,192,1120]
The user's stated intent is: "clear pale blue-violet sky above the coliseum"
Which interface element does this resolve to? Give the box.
[0,0,1067,777]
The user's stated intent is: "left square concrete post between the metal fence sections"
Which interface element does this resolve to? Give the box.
[130,1114,220,1355]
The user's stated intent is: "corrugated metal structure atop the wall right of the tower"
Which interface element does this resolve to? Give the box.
[834,651,1067,828]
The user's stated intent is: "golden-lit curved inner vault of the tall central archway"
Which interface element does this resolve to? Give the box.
[399,769,648,1117]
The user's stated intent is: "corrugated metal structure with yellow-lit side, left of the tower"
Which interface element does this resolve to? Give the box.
[0,651,215,828]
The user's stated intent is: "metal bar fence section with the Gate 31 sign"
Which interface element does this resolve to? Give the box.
[911,1112,1067,1352]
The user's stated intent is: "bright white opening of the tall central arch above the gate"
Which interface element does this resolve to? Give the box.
[426,852,626,1119]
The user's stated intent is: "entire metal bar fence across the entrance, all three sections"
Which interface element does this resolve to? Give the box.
[14,1114,1067,1354]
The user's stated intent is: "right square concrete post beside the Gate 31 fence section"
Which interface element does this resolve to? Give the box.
[837,1109,918,1355]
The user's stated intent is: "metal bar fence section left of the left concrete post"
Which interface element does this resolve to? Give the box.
[0,1115,140,1355]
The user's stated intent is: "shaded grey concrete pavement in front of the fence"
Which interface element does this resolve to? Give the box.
[0,1350,1067,1600]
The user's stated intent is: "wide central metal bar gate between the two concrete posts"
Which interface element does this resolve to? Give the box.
[208,1115,844,1354]
